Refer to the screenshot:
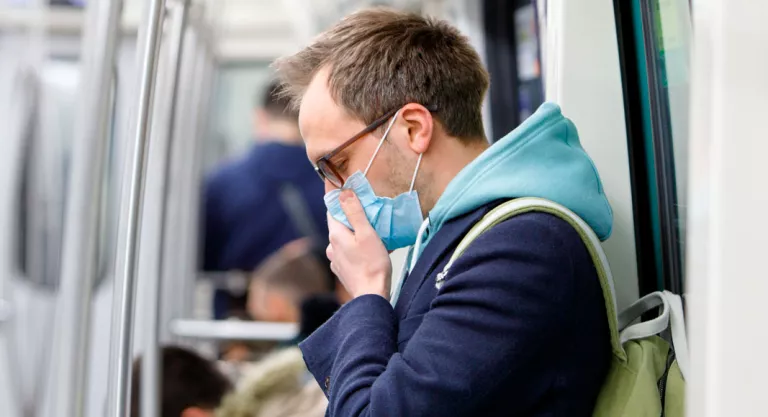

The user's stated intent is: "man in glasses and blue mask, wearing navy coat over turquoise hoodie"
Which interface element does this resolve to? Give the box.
[275,9,613,417]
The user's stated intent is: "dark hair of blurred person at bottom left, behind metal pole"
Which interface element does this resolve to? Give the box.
[131,346,232,417]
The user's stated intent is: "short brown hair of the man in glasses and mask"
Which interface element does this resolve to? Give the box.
[274,8,489,140]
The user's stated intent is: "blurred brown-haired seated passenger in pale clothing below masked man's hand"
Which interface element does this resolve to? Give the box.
[216,241,339,417]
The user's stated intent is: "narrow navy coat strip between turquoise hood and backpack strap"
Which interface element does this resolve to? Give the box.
[395,206,490,320]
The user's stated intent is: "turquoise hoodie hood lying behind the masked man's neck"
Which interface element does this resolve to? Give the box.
[422,103,613,247]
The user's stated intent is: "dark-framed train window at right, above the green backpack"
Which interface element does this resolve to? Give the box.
[614,0,691,293]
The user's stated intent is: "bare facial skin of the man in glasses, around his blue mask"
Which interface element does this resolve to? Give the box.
[299,68,413,197]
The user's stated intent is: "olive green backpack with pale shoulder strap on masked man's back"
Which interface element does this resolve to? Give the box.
[436,197,688,417]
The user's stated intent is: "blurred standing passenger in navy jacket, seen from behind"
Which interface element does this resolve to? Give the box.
[203,80,328,319]
